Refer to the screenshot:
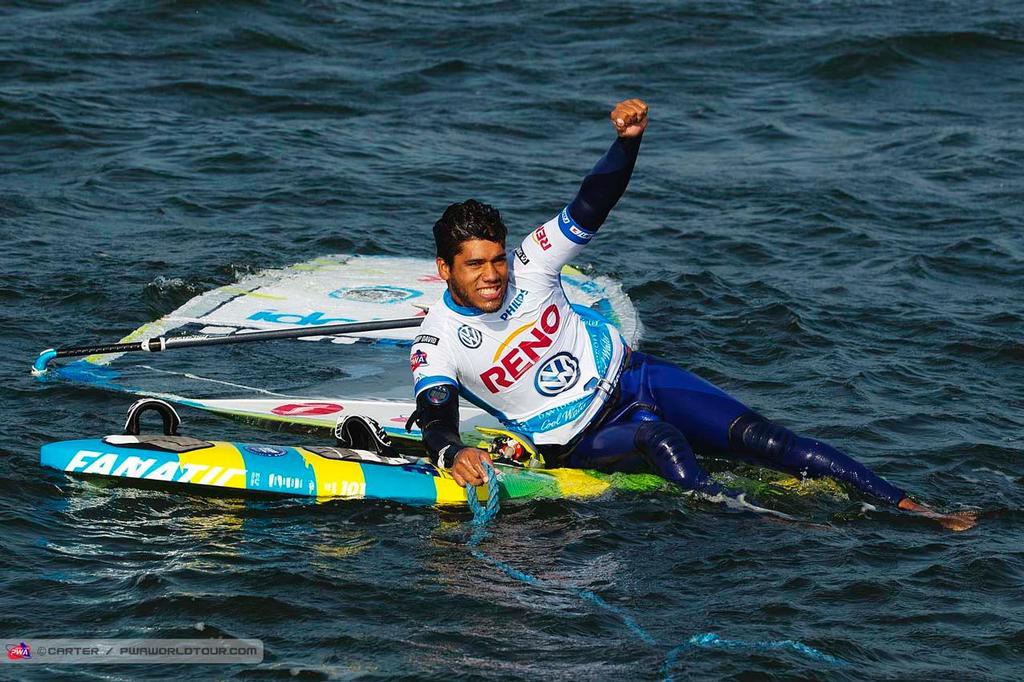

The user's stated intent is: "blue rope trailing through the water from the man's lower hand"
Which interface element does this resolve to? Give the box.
[466,462,847,682]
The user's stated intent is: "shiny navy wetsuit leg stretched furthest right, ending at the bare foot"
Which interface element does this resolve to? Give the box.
[640,355,905,504]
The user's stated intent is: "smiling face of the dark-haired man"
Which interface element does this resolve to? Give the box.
[437,240,509,312]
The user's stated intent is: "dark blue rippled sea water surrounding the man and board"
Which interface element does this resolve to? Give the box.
[0,0,1024,680]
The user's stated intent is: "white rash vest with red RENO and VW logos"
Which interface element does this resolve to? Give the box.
[410,207,627,444]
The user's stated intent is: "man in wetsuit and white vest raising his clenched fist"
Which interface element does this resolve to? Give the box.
[411,99,974,529]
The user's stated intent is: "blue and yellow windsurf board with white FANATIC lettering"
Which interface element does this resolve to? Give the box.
[40,438,664,505]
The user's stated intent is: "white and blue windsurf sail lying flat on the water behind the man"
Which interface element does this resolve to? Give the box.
[49,249,643,425]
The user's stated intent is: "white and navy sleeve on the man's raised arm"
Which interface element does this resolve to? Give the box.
[516,136,642,273]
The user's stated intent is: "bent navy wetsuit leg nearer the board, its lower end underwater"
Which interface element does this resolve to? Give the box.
[565,414,723,495]
